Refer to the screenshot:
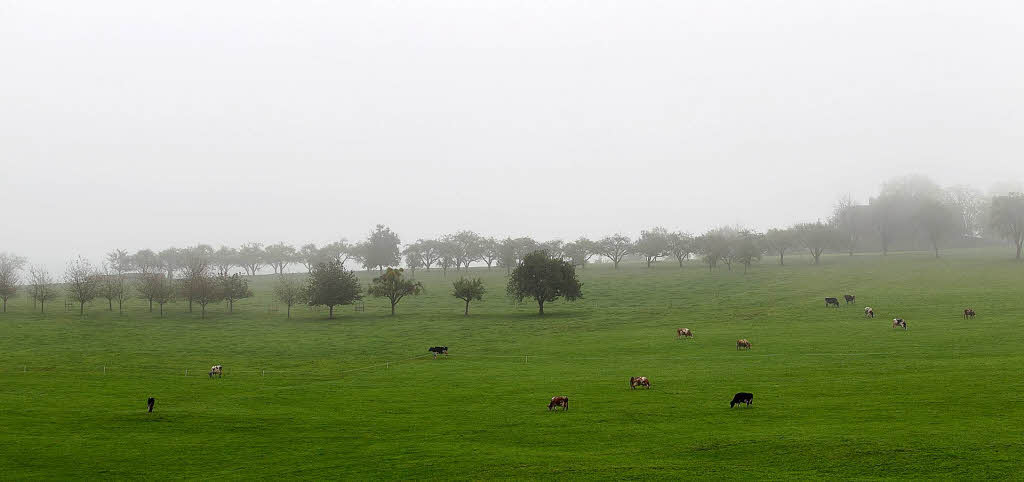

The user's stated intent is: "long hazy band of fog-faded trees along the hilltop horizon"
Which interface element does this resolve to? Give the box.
[0,176,1024,315]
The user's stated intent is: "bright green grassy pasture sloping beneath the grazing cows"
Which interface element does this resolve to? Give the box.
[0,251,1024,479]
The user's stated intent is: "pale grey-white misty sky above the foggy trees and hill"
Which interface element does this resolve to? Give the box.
[0,0,1024,273]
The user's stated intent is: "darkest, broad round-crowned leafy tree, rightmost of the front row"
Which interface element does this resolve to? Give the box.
[507,251,583,315]
